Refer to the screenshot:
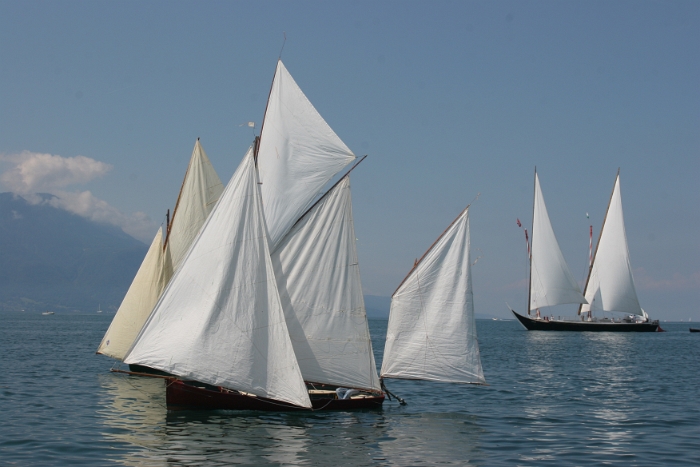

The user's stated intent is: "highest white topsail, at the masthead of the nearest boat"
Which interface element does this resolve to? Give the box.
[258,60,355,249]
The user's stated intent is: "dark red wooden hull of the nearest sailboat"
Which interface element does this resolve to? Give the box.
[165,379,384,412]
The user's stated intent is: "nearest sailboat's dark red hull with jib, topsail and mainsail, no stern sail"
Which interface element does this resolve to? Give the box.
[124,60,385,411]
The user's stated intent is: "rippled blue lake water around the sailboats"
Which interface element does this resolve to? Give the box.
[0,313,700,466]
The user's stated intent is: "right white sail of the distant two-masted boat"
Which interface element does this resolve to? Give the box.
[581,175,644,316]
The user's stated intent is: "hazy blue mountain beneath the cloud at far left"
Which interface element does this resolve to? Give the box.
[0,193,148,311]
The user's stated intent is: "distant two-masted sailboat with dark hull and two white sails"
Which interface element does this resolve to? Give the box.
[511,171,660,332]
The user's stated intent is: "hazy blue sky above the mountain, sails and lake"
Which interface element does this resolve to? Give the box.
[0,0,700,321]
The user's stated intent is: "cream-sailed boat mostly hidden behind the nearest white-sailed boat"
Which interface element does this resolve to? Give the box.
[97,138,223,366]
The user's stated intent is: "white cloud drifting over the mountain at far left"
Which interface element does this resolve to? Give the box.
[0,151,157,242]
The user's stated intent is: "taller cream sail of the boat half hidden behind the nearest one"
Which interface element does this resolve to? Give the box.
[167,139,224,271]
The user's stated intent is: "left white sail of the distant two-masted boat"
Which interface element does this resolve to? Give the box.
[530,173,586,310]
